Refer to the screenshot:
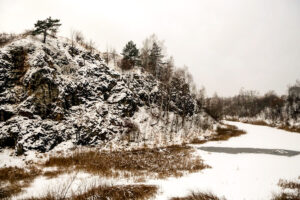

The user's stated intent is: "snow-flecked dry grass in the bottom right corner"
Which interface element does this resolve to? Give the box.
[272,176,300,200]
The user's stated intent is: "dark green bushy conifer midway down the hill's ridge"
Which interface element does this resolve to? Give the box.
[121,41,139,70]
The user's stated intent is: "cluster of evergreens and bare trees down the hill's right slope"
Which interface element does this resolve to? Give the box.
[119,35,210,123]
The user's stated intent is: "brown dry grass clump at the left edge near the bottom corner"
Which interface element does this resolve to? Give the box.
[0,167,41,199]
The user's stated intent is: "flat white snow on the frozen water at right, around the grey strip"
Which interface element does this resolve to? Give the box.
[150,121,300,200]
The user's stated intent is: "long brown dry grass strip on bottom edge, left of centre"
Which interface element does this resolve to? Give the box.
[28,185,158,200]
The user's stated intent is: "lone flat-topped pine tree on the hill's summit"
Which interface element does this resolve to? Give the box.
[32,17,61,43]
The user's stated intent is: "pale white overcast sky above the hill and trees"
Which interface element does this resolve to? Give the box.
[0,0,300,96]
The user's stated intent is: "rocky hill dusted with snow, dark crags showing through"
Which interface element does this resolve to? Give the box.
[0,36,217,154]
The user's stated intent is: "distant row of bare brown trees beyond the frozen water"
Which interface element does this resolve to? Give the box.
[206,81,300,122]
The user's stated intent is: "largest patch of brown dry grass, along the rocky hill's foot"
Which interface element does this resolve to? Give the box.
[44,146,208,178]
